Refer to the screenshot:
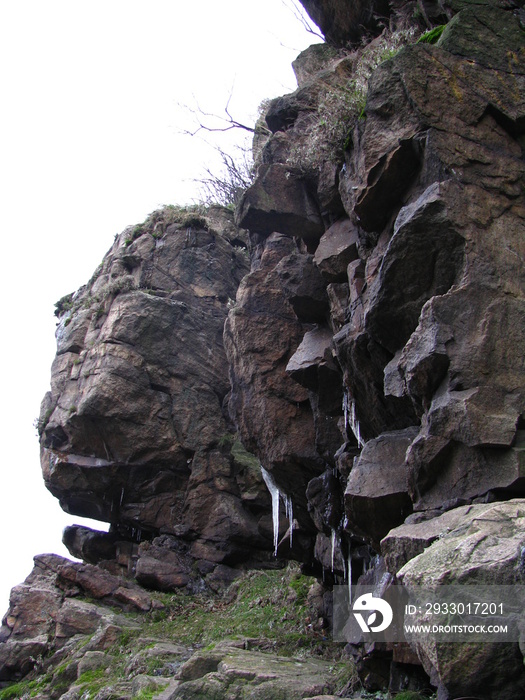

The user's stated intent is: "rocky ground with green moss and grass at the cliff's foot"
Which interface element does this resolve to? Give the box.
[0,568,360,700]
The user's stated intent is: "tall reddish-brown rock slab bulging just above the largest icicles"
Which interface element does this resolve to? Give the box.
[224,234,322,522]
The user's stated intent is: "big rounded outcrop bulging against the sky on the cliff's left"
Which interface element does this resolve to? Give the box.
[36,208,271,576]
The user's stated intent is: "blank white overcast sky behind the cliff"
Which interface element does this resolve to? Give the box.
[0,0,318,615]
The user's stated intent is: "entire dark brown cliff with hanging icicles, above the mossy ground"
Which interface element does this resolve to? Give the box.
[0,0,525,700]
